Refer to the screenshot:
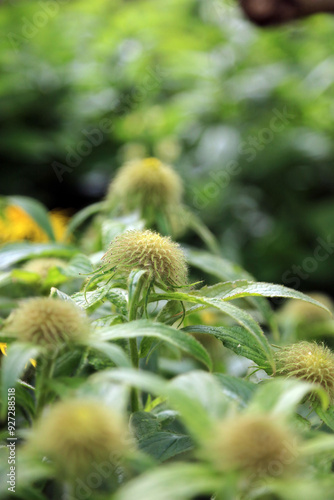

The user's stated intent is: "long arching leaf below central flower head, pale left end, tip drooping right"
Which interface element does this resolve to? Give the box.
[97,320,212,369]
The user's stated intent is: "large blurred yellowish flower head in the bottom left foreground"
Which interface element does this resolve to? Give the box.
[28,400,128,479]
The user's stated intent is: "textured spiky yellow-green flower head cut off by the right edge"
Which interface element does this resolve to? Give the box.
[276,341,334,402]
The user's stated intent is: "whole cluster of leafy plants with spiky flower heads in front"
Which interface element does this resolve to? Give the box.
[0,159,334,500]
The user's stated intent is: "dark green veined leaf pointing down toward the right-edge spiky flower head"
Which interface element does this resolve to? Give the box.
[183,325,268,368]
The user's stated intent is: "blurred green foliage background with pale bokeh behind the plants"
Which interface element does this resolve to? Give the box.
[0,0,334,295]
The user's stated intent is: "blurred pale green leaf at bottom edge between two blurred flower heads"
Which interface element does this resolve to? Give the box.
[113,463,223,500]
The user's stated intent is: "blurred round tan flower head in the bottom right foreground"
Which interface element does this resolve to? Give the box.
[208,414,297,476]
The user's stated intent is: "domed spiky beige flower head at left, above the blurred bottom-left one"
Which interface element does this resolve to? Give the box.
[3,297,89,347]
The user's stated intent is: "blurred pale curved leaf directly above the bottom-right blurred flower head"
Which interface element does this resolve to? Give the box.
[248,377,329,417]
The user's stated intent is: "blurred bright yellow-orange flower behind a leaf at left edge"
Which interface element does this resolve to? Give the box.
[0,205,69,243]
